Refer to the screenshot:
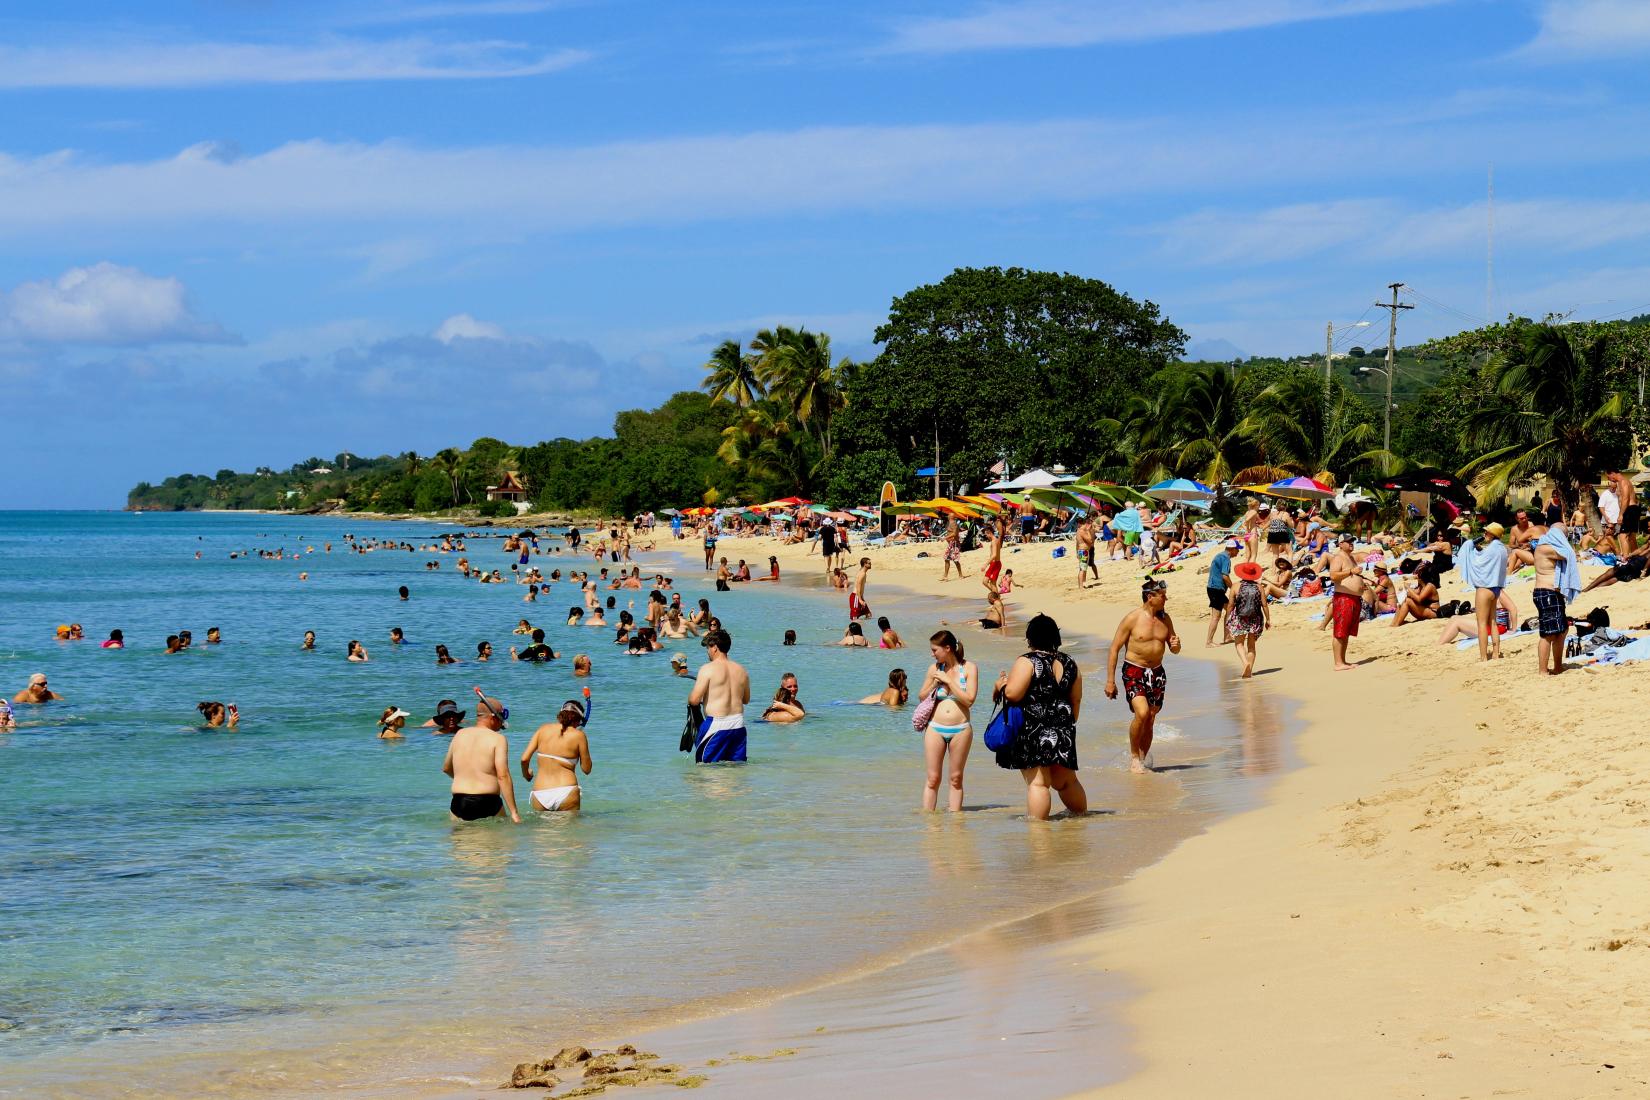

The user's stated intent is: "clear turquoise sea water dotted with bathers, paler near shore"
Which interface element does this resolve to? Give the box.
[0,513,1275,1093]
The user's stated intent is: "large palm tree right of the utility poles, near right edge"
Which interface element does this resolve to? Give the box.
[1460,325,1632,501]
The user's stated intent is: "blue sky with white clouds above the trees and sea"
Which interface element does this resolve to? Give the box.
[0,0,1650,508]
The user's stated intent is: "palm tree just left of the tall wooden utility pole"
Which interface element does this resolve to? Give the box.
[1234,374,1401,485]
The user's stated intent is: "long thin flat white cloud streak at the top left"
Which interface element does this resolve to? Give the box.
[0,38,589,87]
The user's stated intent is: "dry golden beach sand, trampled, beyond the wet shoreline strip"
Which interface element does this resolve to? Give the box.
[699,527,1650,1097]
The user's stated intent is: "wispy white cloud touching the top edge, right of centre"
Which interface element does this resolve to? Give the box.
[884,0,1447,53]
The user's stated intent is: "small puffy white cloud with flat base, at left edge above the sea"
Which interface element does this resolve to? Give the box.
[0,261,233,345]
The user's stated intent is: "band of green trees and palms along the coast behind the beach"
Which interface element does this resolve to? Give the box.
[127,267,1650,516]
